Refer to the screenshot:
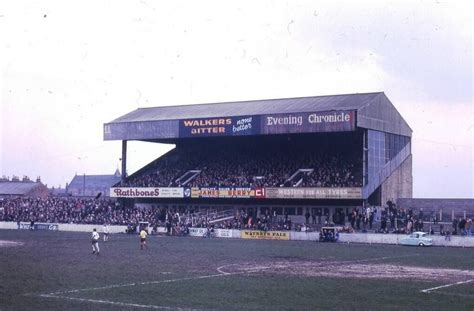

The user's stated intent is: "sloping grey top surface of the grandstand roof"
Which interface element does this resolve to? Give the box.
[110,92,383,123]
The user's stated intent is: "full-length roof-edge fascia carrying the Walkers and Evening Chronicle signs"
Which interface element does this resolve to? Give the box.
[103,110,356,140]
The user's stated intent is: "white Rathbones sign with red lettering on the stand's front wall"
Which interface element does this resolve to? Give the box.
[110,187,184,198]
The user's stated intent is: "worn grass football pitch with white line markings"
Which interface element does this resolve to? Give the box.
[0,230,474,311]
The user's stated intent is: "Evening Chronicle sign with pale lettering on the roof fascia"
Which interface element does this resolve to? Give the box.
[261,110,355,134]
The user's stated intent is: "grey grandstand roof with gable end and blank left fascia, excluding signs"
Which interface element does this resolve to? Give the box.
[104,92,412,143]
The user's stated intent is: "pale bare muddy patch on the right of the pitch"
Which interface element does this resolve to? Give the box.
[220,261,474,282]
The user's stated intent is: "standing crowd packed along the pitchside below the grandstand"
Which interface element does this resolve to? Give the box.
[0,197,473,236]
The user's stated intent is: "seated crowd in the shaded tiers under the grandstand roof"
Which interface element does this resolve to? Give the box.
[125,140,362,188]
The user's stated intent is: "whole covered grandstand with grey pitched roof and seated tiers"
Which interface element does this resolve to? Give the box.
[104,92,412,218]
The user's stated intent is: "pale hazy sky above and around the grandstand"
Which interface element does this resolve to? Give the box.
[0,0,474,198]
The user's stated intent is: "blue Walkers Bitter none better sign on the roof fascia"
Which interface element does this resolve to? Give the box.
[179,116,259,137]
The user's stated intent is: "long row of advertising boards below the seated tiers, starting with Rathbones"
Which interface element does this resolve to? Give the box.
[110,187,362,200]
